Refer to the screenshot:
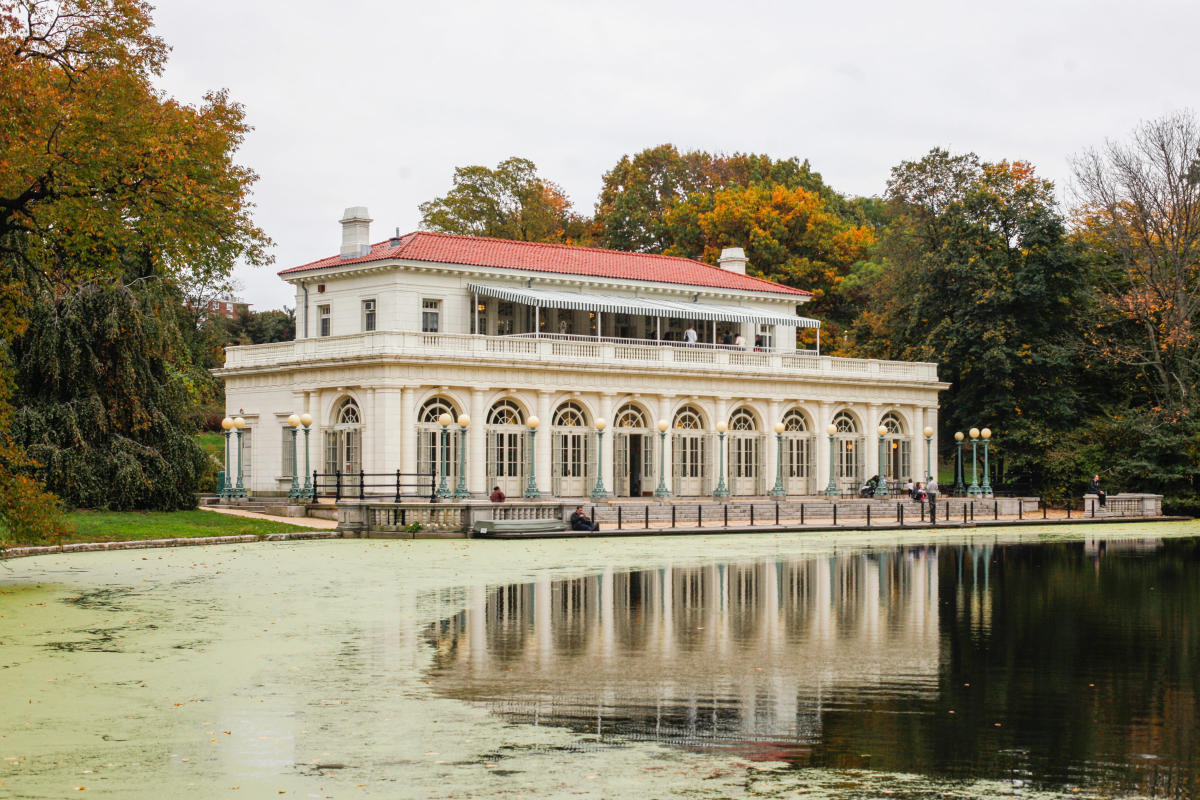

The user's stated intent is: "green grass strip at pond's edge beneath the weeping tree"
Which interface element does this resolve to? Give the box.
[57,511,313,542]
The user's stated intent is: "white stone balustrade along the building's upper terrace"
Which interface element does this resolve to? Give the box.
[221,331,937,381]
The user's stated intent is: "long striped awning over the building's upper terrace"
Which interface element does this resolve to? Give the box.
[467,283,821,327]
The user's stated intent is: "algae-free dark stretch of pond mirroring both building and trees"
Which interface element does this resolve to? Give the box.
[426,541,1200,798]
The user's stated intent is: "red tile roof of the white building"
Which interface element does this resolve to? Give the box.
[280,230,812,296]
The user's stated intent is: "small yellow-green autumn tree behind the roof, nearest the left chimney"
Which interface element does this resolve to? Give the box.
[420,157,588,243]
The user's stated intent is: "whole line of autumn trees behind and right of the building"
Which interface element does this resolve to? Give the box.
[421,123,1200,513]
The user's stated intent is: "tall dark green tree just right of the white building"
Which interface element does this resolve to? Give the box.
[851,149,1094,487]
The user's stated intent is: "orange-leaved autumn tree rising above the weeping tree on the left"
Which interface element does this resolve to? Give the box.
[0,0,269,537]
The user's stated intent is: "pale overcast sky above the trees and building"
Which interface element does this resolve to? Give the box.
[156,0,1200,309]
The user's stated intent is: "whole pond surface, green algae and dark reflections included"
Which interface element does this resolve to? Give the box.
[0,523,1200,798]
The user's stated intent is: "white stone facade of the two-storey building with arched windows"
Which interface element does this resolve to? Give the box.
[218,209,947,498]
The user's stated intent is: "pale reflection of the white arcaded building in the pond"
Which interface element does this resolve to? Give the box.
[427,547,940,752]
